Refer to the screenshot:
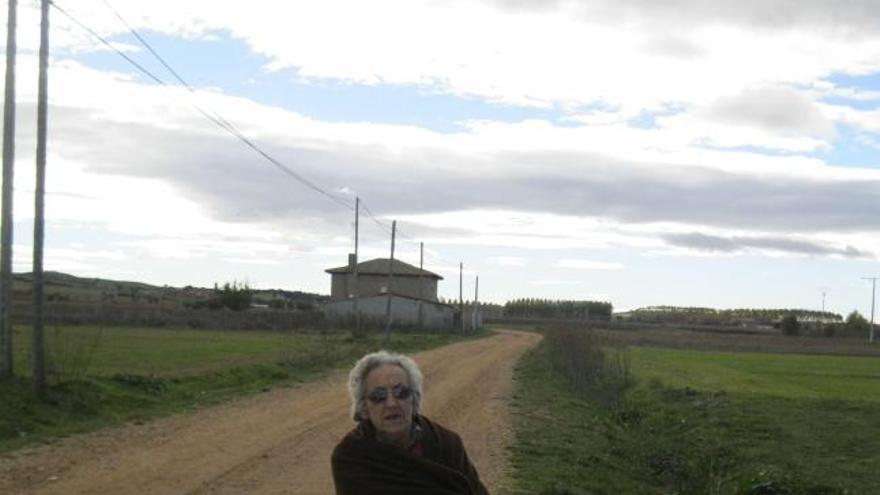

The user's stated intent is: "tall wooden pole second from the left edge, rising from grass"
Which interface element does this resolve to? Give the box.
[33,0,50,396]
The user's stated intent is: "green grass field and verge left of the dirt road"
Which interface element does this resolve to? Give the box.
[0,327,486,452]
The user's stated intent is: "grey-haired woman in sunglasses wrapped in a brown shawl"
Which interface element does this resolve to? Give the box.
[331,351,488,495]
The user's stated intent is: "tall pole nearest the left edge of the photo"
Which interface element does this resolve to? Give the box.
[0,0,18,379]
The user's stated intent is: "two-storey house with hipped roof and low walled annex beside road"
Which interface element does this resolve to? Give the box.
[324,255,456,329]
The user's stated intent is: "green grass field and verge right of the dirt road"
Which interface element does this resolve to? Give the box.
[513,332,880,495]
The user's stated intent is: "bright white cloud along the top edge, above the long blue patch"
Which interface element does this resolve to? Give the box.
[31,0,880,113]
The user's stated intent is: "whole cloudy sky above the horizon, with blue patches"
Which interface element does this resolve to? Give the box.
[3,0,880,313]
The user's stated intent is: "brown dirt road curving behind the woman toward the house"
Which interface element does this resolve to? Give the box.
[0,332,539,495]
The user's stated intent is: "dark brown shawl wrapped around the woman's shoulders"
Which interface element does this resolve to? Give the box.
[331,416,489,495]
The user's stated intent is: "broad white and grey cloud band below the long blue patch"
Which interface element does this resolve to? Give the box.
[19,58,880,252]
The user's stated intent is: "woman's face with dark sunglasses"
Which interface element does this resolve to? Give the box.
[366,364,413,441]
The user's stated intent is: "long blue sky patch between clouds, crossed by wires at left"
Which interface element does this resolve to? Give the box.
[69,32,569,132]
